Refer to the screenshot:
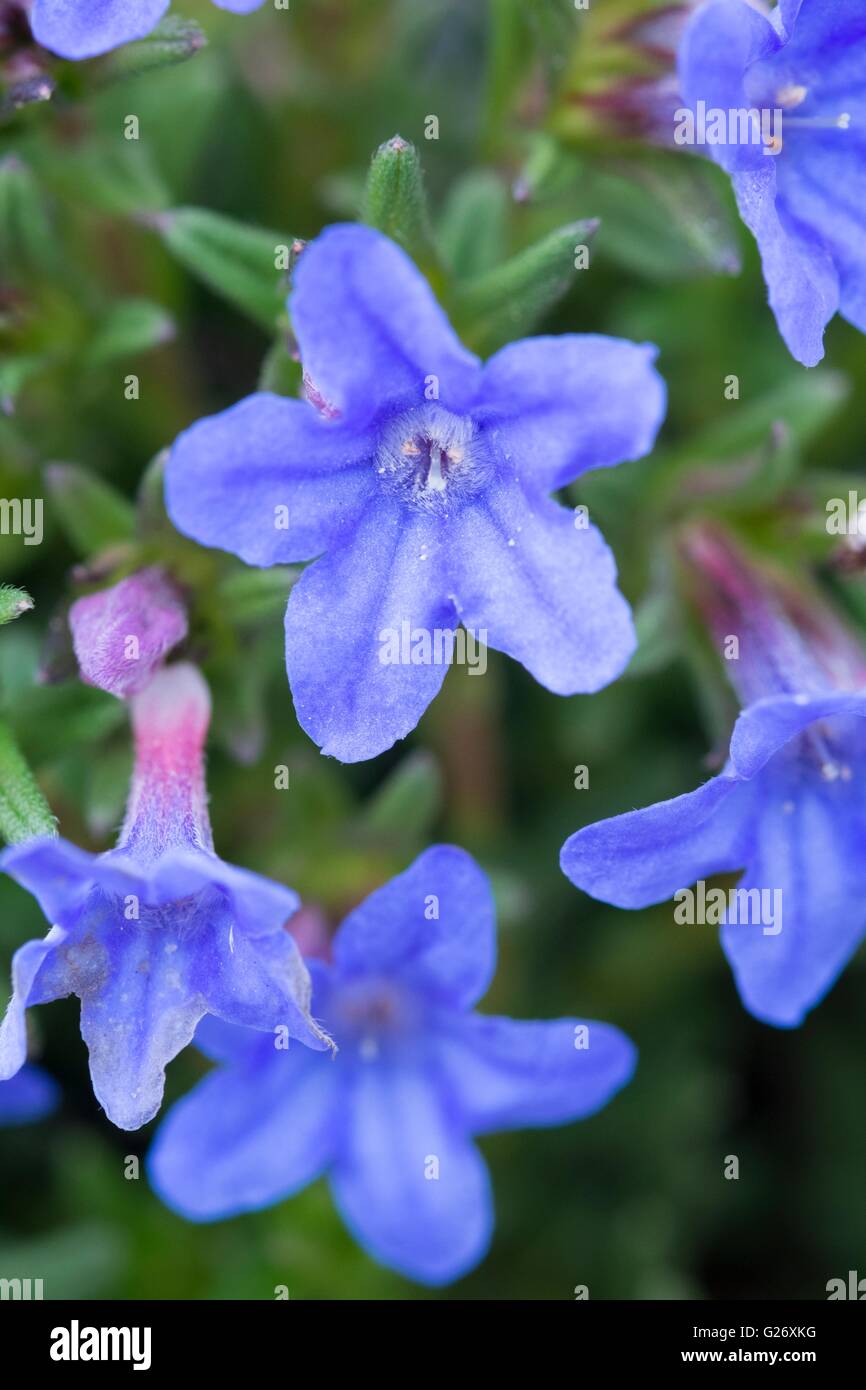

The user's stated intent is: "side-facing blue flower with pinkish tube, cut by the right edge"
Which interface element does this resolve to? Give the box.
[562,532,866,1027]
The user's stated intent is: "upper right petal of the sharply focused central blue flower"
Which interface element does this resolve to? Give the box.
[478,334,667,492]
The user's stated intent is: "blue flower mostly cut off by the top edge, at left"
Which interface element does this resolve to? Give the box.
[31,0,264,58]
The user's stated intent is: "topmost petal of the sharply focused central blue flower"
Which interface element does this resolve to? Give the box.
[289,224,478,425]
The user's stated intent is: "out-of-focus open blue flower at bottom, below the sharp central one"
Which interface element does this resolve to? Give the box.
[149,845,635,1284]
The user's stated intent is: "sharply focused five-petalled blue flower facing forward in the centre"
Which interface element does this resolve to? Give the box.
[167,225,664,762]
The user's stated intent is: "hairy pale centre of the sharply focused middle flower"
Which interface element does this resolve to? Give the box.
[375,404,491,510]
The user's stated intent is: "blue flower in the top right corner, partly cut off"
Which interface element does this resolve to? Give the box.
[678,0,866,367]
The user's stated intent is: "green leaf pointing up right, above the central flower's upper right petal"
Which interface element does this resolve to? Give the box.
[455,221,598,353]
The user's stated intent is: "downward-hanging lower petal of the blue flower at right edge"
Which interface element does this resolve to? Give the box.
[721,758,866,1027]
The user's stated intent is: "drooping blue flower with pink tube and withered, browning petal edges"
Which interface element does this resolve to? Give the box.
[0,664,328,1129]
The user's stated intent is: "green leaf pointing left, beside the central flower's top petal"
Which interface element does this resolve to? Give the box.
[149,207,292,332]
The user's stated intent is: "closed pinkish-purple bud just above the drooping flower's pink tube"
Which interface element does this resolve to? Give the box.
[70,567,188,699]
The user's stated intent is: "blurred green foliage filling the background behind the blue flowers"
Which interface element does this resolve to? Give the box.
[0,0,866,1298]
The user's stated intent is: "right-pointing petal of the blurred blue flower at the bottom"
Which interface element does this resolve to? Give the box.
[445,1013,637,1134]
